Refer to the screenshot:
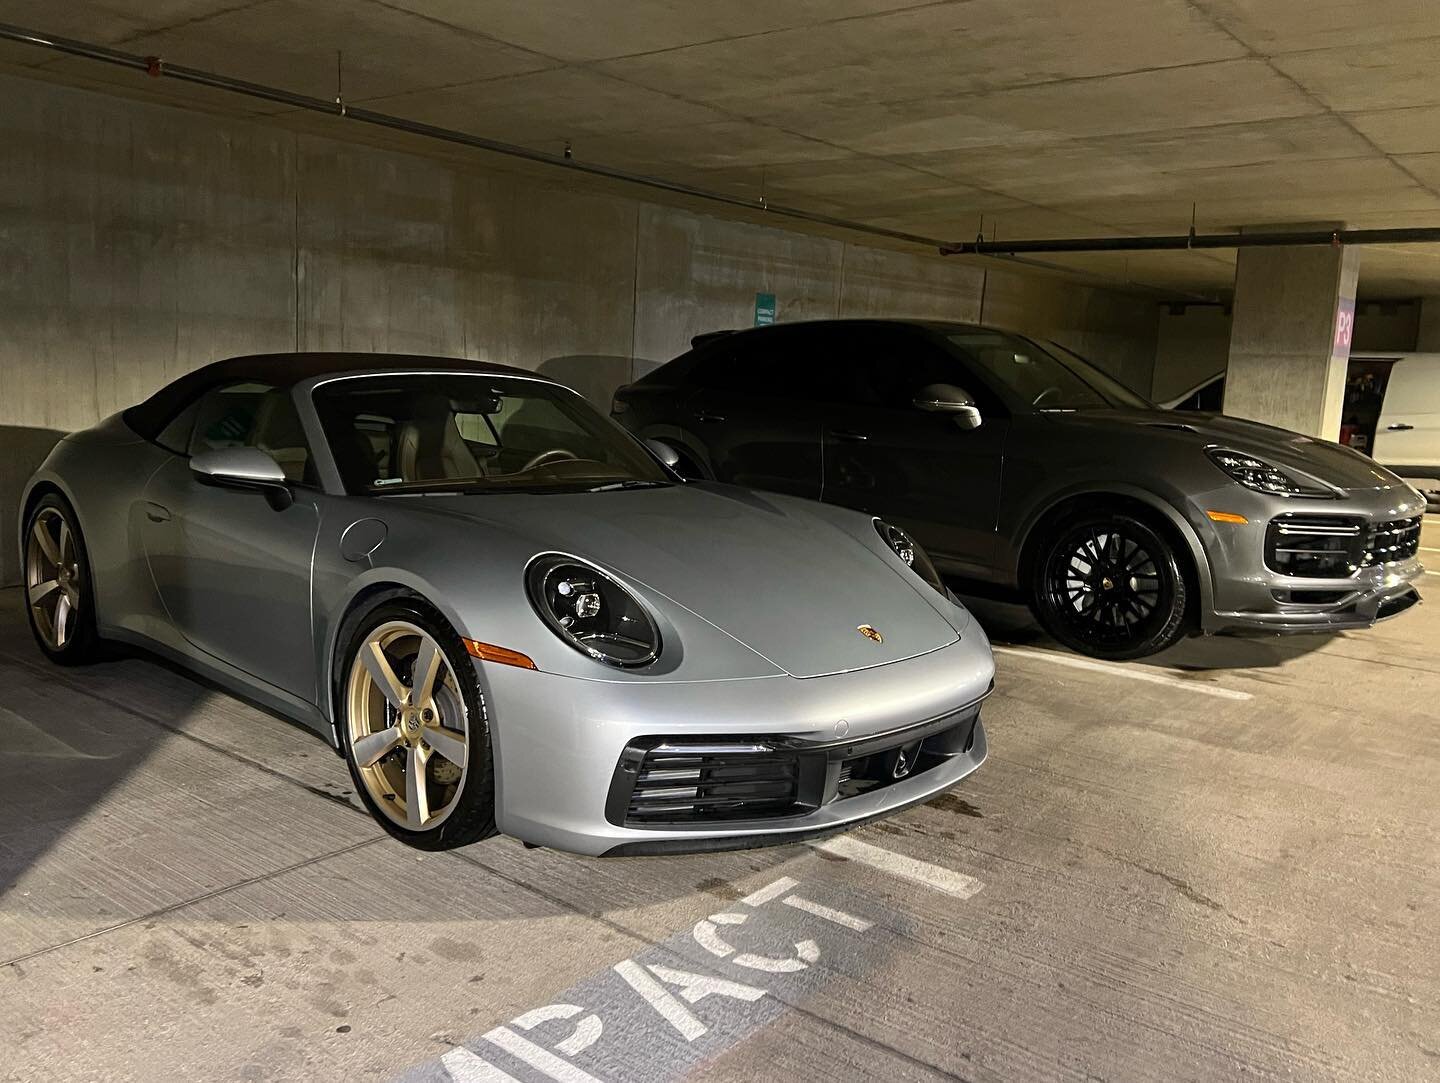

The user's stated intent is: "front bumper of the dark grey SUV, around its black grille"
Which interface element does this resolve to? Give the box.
[1189,487,1426,634]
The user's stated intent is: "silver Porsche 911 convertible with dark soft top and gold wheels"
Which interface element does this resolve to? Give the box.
[20,354,994,854]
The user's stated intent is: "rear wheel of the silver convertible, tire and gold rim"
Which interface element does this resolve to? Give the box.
[20,493,102,665]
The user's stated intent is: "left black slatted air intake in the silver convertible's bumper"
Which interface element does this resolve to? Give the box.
[625,742,809,825]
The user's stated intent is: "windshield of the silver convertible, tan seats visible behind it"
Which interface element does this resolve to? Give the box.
[314,373,670,494]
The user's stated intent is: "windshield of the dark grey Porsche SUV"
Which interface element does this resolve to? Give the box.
[945,330,1153,410]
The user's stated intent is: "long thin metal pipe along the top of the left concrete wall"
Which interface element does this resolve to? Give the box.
[0,23,945,248]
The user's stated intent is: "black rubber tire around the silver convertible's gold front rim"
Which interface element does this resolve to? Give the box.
[336,596,495,850]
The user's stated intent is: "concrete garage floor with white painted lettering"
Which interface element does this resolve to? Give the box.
[0,517,1440,1083]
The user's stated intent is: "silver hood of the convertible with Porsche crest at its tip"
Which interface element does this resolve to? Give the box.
[411,484,958,677]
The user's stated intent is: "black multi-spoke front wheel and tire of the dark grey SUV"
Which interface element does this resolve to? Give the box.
[1030,507,1189,661]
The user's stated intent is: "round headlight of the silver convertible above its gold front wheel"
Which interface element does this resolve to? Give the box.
[526,553,660,668]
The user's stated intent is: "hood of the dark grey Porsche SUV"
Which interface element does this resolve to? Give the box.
[1053,410,1404,490]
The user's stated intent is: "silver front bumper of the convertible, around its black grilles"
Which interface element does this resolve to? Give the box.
[477,624,995,855]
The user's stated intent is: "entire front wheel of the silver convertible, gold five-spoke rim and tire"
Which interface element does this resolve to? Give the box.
[340,599,495,850]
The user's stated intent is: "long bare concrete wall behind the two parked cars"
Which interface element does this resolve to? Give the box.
[0,70,1156,582]
